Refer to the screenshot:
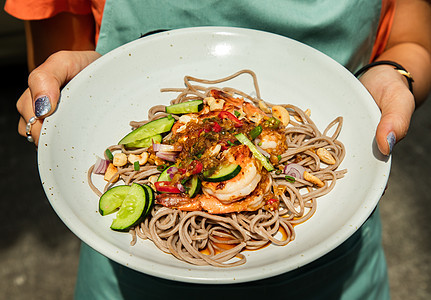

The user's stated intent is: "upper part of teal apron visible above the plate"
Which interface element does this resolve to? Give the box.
[96,0,381,70]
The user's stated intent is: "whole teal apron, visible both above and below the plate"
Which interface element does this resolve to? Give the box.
[75,0,389,300]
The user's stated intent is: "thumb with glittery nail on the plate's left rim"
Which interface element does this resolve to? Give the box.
[28,51,100,120]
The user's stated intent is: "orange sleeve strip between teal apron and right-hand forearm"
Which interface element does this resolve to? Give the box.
[370,0,396,62]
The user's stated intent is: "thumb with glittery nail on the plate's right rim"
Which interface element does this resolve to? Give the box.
[376,87,415,155]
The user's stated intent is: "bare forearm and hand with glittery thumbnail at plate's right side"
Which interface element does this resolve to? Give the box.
[360,0,431,155]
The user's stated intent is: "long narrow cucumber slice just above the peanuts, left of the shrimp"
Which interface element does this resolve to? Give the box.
[118,115,175,145]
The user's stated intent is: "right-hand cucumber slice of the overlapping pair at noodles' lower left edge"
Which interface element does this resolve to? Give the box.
[111,183,148,231]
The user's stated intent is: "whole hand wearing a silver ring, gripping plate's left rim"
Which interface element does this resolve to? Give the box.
[16,51,100,146]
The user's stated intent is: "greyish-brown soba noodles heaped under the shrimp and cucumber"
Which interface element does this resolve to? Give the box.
[88,70,346,267]
